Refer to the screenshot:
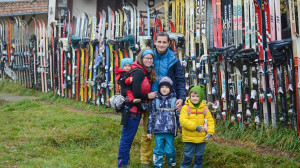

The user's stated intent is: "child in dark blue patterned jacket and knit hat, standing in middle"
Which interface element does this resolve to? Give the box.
[147,77,179,167]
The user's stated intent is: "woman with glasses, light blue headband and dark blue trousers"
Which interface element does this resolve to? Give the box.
[118,49,156,167]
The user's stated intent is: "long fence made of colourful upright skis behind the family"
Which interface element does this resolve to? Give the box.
[0,0,300,133]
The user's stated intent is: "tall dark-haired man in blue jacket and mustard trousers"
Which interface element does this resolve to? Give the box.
[141,32,186,167]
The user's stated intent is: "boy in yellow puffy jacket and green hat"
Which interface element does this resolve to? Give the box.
[179,86,215,168]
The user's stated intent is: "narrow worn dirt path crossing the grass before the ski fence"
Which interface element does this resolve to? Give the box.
[0,93,297,158]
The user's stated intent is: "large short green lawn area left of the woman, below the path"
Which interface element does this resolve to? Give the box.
[0,100,121,167]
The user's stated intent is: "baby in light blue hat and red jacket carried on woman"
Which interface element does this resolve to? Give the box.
[115,58,141,103]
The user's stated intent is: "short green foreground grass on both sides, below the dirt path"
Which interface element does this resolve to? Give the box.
[0,100,300,168]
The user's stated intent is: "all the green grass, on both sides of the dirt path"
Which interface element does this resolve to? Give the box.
[0,82,300,168]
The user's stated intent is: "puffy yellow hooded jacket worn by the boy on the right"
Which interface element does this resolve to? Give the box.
[179,98,215,143]
